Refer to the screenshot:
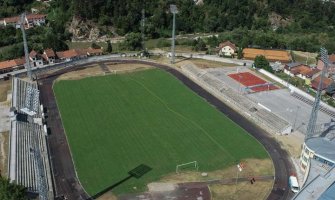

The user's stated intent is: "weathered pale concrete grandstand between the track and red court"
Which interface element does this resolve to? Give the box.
[182,64,292,134]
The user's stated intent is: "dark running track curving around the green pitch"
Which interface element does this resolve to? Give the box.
[39,59,294,200]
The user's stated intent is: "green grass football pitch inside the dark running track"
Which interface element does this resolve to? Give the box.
[54,69,268,195]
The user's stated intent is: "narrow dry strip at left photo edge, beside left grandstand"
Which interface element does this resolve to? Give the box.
[0,132,9,176]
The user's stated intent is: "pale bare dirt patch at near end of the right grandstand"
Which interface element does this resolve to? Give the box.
[276,132,304,158]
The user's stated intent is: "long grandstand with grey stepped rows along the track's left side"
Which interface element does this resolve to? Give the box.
[8,78,53,199]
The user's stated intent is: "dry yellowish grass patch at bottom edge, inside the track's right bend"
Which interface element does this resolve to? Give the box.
[209,180,273,200]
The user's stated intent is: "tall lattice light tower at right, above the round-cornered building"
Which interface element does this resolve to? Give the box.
[305,47,329,140]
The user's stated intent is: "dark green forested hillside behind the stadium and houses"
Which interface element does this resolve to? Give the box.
[0,0,335,60]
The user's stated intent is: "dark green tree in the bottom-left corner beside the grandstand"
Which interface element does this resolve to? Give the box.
[0,176,28,200]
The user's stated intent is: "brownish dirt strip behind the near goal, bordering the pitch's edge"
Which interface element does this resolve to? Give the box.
[161,159,274,183]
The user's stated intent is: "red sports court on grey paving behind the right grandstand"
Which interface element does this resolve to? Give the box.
[228,72,278,92]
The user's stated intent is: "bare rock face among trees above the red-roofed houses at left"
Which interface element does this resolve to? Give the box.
[69,17,101,41]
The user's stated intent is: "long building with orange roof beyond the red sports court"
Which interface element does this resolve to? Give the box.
[243,48,291,63]
